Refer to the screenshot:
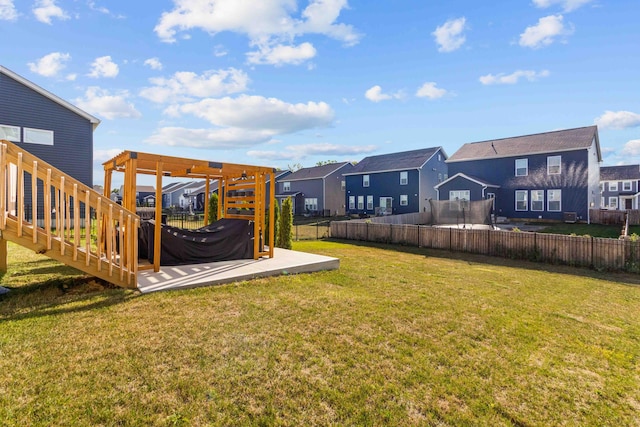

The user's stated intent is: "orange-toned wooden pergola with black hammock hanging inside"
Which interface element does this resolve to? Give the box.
[103,151,275,272]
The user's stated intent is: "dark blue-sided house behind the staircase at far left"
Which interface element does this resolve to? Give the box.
[0,66,100,214]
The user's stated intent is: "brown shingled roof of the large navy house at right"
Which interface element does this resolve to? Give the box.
[447,126,602,163]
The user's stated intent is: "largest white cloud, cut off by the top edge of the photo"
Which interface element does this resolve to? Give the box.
[154,0,361,64]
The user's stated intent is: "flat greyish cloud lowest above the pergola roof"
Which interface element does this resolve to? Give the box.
[145,127,272,149]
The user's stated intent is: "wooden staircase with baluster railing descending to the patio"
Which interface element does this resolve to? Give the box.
[0,140,140,289]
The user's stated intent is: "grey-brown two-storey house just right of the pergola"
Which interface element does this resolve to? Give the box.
[276,162,353,216]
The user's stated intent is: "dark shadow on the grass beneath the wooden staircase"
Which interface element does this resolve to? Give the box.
[0,272,138,322]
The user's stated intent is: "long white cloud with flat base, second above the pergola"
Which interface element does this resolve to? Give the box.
[166,95,334,135]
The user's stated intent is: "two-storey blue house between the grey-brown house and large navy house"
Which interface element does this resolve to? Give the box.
[344,147,448,215]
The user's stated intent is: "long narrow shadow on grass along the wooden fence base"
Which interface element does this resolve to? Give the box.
[326,238,640,286]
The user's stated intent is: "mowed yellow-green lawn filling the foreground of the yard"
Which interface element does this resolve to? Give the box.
[0,241,640,426]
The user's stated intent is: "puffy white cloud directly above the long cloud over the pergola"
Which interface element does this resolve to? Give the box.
[140,68,249,103]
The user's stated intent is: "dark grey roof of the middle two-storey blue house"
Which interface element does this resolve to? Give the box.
[344,147,447,175]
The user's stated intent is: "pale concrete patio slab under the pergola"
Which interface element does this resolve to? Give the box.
[138,248,340,293]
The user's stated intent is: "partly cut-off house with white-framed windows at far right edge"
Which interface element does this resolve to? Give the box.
[600,165,640,210]
